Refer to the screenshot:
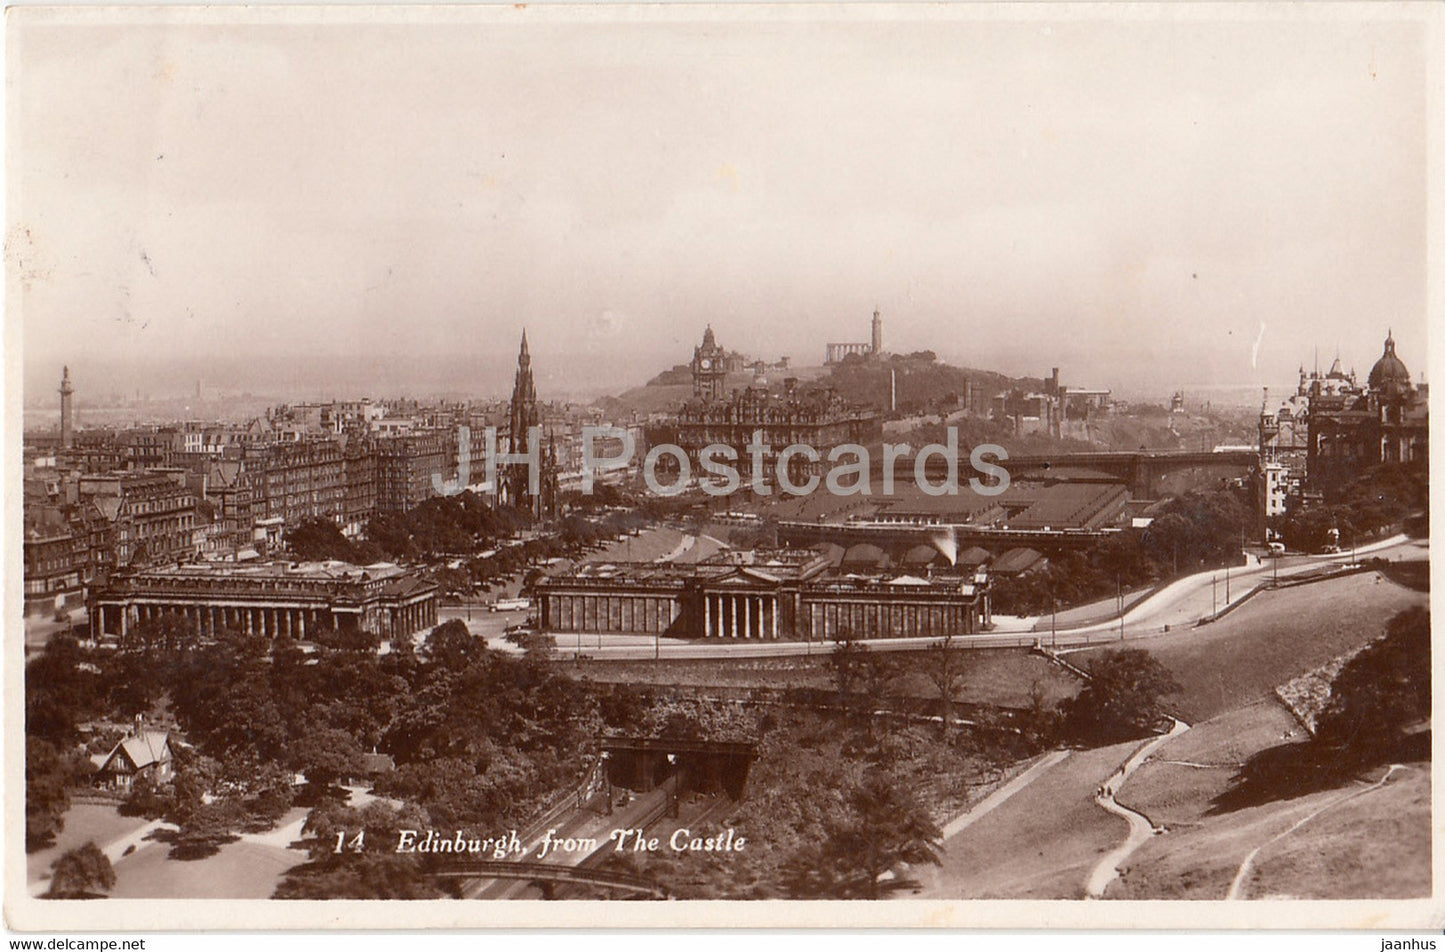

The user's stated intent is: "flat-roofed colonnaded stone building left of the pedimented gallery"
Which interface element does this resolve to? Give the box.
[90,562,436,641]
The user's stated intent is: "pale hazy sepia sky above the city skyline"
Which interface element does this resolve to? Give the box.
[7,7,1426,396]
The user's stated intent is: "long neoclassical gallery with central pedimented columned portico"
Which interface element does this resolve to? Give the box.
[535,550,988,640]
